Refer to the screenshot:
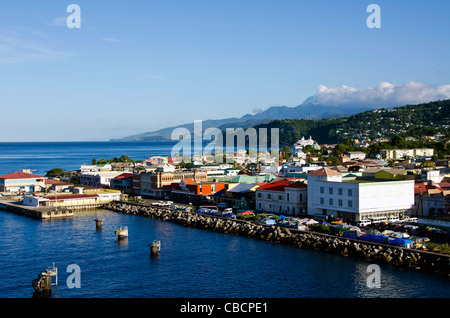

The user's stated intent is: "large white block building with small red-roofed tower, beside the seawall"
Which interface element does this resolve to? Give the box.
[308,168,414,221]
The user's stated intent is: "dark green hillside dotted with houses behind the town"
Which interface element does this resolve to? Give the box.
[255,100,450,145]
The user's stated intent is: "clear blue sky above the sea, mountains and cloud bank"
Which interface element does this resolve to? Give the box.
[0,0,450,141]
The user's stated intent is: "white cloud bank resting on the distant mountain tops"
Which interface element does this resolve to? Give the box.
[305,81,450,108]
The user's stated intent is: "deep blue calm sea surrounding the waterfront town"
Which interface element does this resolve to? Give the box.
[0,143,450,299]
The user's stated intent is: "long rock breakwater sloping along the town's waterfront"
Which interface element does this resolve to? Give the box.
[105,201,450,276]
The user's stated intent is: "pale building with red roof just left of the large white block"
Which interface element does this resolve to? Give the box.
[255,179,308,216]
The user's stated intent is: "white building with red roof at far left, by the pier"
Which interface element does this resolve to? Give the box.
[0,170,47,193]
